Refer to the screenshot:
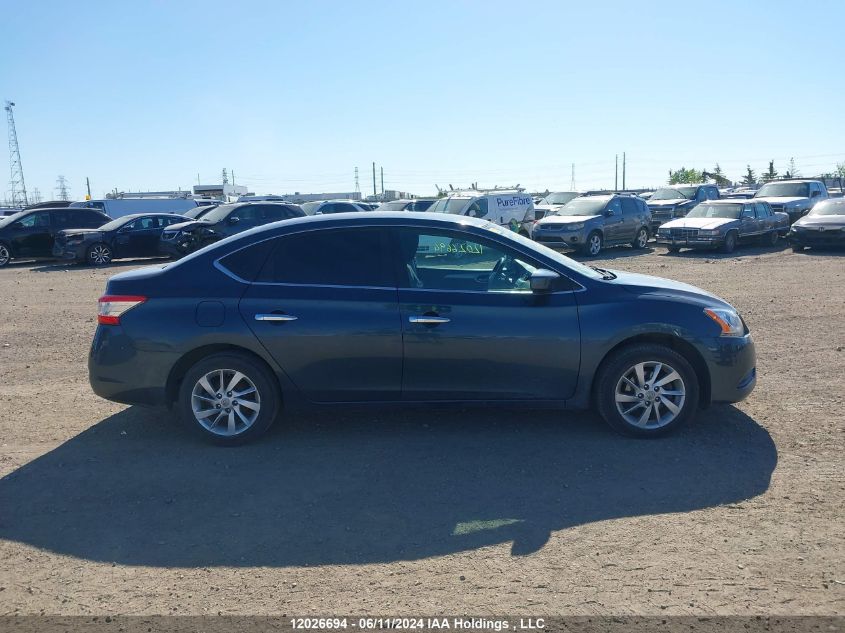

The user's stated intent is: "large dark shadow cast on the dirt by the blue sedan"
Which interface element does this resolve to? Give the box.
[0,407,777,567]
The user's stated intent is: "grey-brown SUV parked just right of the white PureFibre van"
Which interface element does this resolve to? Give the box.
[532,194,651,257]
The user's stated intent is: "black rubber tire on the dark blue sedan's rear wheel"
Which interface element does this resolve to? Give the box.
[176,352,281,446]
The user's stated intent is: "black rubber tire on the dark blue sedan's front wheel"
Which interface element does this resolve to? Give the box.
[594,343,699,437]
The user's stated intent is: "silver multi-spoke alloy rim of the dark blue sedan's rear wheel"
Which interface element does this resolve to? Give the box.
[191,369,261,437]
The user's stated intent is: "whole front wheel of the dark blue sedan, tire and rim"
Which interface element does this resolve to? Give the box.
[595,344,699,437]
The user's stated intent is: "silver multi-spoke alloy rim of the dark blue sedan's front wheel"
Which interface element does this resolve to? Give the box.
[615,361,686,429]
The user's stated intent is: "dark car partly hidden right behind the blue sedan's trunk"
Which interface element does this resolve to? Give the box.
[159,202,305,258]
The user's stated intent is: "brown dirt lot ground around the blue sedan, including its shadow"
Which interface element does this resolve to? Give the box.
[0,241,845,615]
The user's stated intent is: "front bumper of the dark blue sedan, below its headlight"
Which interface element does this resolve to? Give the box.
[704,334,757,402]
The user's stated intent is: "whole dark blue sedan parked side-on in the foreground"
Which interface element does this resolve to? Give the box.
[89,212,756,444]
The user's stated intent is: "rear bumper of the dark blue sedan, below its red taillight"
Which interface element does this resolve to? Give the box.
[88,325,178,406]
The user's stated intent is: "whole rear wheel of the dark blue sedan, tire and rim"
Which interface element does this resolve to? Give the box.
[178,353,281,446]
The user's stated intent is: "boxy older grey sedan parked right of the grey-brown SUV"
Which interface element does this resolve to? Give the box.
[657,200,789,253]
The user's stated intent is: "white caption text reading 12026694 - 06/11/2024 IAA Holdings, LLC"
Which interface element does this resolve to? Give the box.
[290,617,545,632]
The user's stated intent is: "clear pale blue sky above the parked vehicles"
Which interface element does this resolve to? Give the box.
[0,0,845,199]
